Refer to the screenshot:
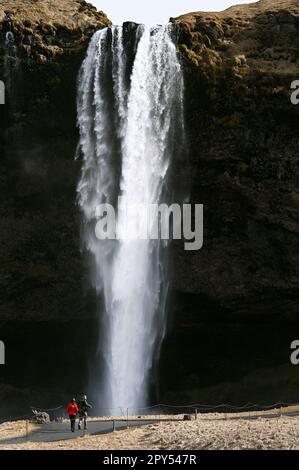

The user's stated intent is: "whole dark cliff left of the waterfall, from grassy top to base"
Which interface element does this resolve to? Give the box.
[0,0,110,416]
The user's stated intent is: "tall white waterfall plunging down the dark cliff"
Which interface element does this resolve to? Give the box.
[77,25,184,413]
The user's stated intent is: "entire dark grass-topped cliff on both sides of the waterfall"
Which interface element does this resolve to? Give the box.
[0,0,299,407]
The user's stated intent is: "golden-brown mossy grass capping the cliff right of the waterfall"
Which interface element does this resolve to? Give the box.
[171,0,299,79]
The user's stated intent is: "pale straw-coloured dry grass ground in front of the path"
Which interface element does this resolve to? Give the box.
[0,413,299,450]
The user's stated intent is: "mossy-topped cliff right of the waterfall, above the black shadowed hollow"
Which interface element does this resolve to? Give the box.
[173,1,299,316]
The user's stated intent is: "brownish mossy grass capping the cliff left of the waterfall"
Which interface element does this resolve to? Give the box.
[0,0,111,63]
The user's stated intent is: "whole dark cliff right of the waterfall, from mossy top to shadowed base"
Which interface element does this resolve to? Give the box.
[163,1,299,403]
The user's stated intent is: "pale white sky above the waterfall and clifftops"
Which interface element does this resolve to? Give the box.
[88,0,253,26]
